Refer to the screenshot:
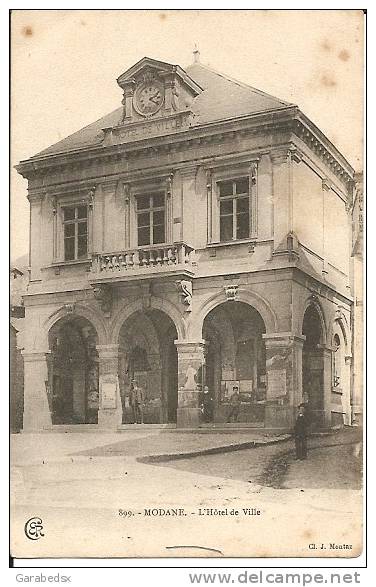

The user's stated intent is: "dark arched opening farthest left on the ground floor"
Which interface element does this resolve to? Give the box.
[48,316,99,424]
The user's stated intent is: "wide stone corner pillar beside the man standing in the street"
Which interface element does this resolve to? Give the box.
[262,332,305,429]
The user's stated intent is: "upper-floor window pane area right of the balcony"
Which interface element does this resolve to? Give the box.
[218,177,250,241]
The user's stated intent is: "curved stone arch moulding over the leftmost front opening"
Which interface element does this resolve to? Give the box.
[40,304,108,349]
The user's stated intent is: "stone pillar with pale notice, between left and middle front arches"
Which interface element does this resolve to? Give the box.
[97,344,123,430]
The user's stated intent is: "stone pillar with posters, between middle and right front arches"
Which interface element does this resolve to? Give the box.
[175,341,205,428]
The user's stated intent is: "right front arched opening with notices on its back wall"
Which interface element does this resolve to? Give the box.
[203,301,266,425]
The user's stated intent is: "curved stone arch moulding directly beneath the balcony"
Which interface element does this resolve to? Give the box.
[110,296,186,344]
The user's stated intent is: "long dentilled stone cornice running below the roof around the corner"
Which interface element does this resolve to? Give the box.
[16,106,354,194]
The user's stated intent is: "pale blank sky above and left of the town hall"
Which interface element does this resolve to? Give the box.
[11,10,363,259]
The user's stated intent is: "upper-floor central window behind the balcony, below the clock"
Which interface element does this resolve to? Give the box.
[136,193,166,247]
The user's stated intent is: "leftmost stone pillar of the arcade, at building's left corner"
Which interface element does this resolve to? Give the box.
[22,351,52,432]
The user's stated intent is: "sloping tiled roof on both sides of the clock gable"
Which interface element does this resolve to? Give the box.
[30,60,293,158]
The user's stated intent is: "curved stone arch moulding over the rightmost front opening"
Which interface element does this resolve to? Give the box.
[191,289,278,339]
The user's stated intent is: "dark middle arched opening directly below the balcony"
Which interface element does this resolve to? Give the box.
[119,309,178,424]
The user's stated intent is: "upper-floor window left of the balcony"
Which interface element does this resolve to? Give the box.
[63,204,88,261]
